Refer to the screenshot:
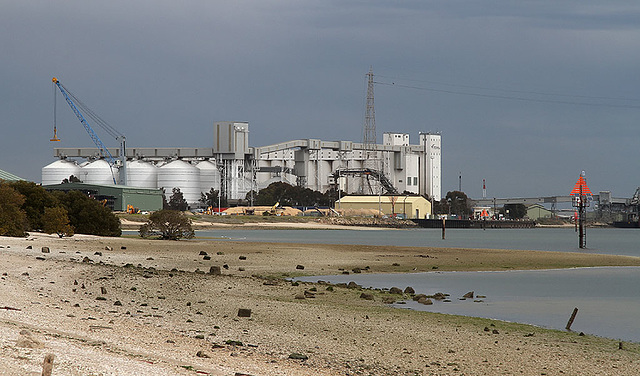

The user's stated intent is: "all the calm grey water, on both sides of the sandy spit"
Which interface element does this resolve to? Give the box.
[131,228,640,342]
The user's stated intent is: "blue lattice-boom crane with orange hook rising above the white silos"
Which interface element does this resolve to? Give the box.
[51,77,127,185]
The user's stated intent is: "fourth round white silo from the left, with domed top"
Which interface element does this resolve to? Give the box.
[158,159,200,204]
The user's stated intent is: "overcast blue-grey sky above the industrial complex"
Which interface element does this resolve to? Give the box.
[0,0,640,198]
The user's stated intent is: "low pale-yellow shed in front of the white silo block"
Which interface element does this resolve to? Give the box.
[336,196,431,219]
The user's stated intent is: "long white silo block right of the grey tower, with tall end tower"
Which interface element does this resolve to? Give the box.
[255,133,441,200]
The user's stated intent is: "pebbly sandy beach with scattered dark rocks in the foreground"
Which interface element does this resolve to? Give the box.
[0,234,640,376]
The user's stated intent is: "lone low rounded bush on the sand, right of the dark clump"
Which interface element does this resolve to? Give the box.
[140,210,195,240]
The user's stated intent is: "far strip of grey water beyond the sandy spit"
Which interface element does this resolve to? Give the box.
[196,228,640,256]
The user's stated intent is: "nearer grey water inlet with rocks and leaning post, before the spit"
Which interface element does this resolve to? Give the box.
[298,267,640,342]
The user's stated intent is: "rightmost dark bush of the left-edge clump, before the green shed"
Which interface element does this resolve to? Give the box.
[53,191,122,236]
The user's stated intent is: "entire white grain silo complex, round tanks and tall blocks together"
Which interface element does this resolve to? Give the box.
[42,122,441,206]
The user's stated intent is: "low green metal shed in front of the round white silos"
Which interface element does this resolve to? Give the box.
[43,183,162,211]
